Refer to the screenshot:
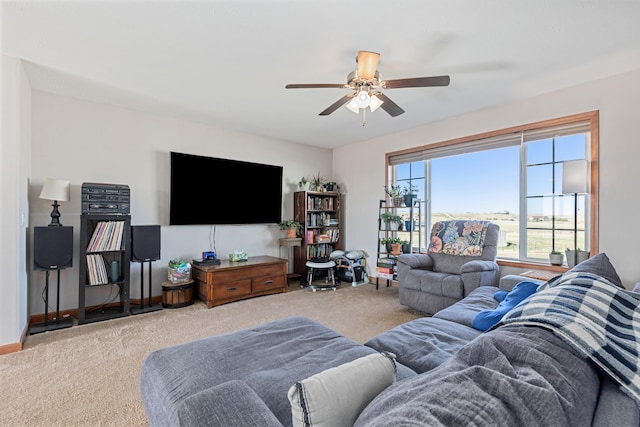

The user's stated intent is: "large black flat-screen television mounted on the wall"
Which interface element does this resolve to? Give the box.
[169,152,282,225]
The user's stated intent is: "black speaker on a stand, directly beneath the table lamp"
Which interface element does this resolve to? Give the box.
[33,227,73,270]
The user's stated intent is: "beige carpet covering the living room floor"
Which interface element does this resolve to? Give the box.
[0,284,421,426]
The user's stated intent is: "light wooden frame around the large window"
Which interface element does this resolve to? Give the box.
[385,110,600,271]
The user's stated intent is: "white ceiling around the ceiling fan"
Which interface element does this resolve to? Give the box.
[2,0,640,147]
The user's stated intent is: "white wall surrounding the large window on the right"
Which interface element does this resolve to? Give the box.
[333,70,640,288]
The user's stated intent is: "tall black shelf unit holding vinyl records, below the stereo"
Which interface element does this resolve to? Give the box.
[78,214,131,325]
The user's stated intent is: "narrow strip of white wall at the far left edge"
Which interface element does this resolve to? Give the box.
[0,55,31,345]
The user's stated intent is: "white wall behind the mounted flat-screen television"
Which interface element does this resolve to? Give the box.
[29,91,332,315]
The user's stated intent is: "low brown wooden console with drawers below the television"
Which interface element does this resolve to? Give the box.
[192,256,287,308]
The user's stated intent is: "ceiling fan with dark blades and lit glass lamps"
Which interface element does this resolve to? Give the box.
[285,50,450,118]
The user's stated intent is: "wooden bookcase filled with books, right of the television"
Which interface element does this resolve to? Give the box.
[293,191,343,275]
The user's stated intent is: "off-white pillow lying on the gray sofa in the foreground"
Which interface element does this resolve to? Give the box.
[287,352,396,427]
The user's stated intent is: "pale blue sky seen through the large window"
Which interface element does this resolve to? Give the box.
[397,134,586,215]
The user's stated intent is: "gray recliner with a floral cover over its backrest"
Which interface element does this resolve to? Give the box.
[397,220,500,314]
